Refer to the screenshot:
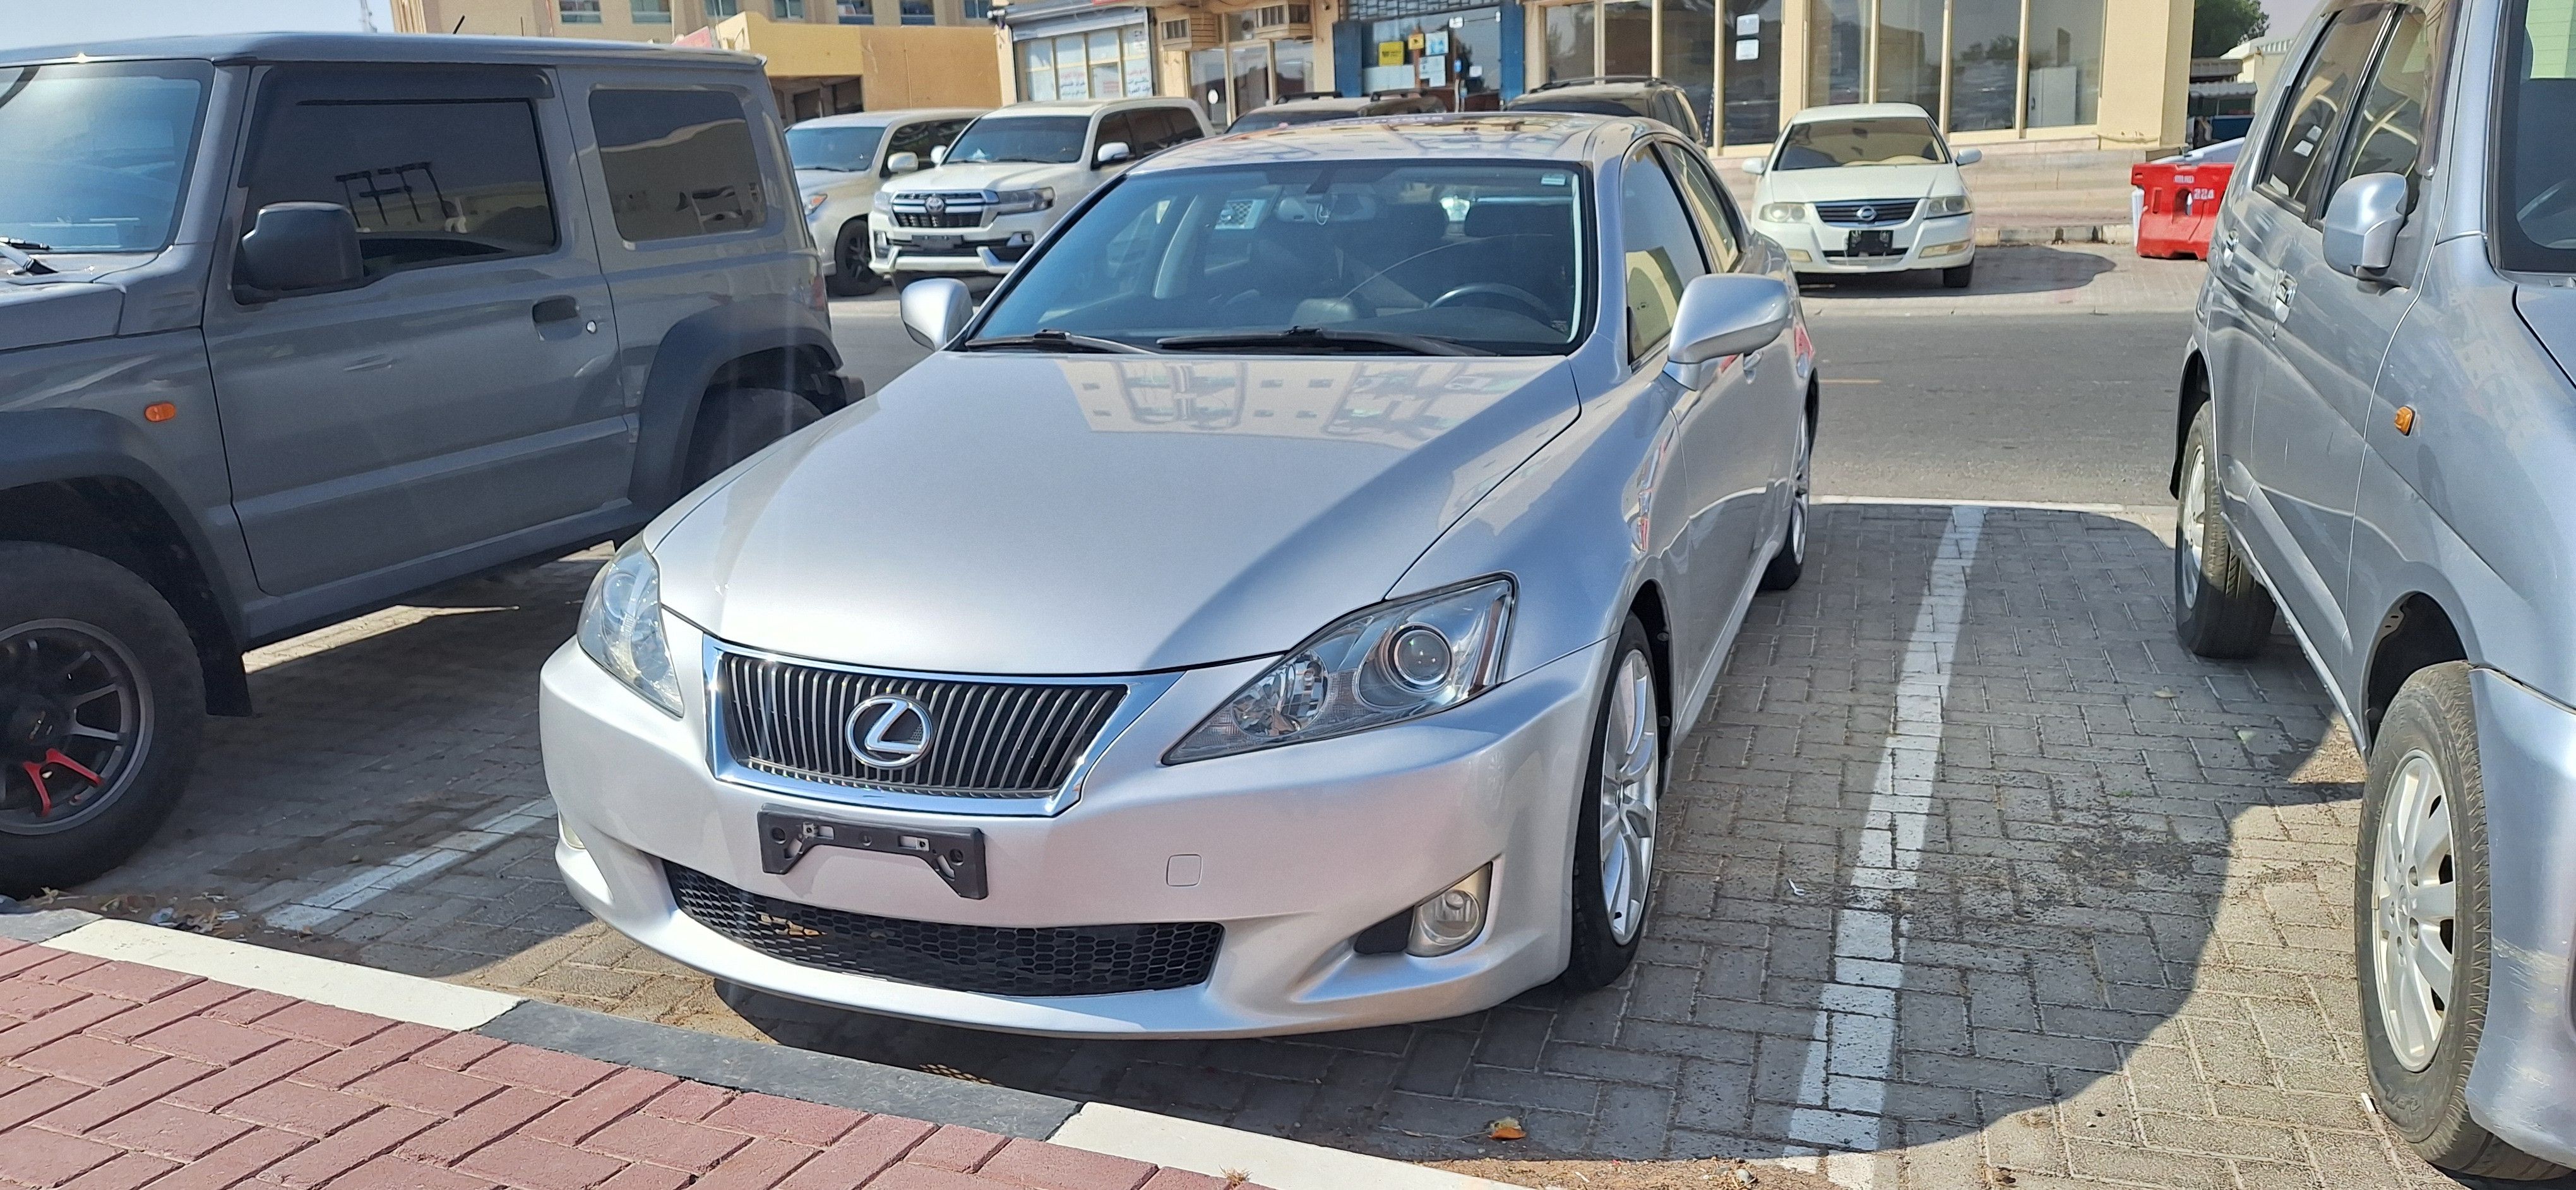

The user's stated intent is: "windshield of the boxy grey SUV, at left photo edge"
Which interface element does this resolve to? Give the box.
[0,62,214,253]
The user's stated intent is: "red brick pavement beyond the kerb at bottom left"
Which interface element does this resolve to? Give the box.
[0,937,1246,1190]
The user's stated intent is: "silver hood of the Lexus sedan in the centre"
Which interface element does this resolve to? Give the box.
[652,353,1579,675]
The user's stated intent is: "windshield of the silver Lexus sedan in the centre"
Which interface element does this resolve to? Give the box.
[976,162,1592,356]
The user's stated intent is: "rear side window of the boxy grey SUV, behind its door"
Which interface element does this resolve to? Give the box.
[590,90,768,244]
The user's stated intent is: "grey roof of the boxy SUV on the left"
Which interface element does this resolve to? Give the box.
[0,33,760,69]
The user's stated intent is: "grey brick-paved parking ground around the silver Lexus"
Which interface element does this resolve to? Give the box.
[65,505,2445,1190]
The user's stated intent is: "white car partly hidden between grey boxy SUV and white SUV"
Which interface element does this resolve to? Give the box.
[788,108,984,296]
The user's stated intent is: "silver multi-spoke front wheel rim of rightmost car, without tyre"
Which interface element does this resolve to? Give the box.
[2370,750,2460,1071]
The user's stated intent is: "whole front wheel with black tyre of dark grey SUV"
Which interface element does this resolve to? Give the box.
[0,543,206,896]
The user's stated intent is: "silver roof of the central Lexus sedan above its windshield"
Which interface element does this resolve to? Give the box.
[1131,111,1638,172]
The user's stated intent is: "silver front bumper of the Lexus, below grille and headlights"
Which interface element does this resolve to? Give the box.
[541,618,1605,1035]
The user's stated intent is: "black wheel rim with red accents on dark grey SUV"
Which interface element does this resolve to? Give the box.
[0,621,152,834]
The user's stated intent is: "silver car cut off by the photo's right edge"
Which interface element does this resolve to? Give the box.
[2174,0,2576,1180]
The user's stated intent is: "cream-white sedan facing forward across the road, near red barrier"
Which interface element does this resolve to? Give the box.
[1744,103,1984,289]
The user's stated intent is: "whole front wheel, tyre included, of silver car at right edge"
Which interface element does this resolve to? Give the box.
[2352,662,2566,1180]
